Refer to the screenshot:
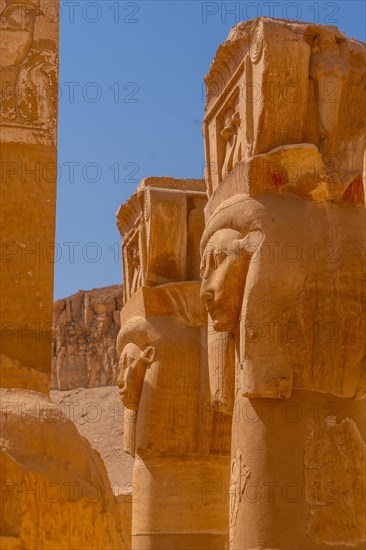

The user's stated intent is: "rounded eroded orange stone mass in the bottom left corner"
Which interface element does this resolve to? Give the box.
[0,390,129,550]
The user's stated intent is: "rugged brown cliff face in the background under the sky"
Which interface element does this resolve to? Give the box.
[52,285,122,390]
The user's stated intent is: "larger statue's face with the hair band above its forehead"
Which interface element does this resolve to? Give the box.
[201,195,263,332]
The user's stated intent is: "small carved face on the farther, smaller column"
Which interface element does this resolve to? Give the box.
[117,343,155,411]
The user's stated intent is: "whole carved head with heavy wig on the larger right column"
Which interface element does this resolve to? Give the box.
[201,192,366,399]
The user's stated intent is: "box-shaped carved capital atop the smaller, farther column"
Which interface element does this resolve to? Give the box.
[117,178,206,300]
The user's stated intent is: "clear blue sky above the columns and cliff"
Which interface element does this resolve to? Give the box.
[54,0,366,299]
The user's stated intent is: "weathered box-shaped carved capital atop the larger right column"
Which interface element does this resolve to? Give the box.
[203,17,366,196]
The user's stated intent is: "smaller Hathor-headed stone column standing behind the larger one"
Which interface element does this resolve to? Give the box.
[117,178,230,550]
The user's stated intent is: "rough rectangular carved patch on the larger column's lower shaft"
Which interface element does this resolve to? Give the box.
[305,417,366,546]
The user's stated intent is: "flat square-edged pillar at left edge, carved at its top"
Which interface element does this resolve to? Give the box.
[0,0,58,392]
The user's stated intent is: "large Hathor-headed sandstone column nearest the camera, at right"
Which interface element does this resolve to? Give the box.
[201,18,366,550]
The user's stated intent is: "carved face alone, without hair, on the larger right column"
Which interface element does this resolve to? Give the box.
[201,229,260,332]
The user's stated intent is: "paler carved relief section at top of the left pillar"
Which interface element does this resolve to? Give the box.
[0,0,58,143]
